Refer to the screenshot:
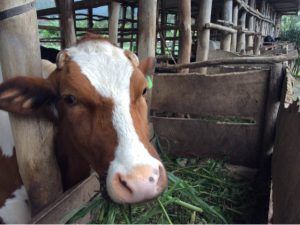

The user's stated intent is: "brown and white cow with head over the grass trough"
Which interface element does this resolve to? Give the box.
[0,35,167,223]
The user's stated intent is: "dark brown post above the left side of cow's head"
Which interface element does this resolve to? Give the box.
[58,0,76,48]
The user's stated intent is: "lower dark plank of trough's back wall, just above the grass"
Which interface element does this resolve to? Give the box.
[151,117,261,168]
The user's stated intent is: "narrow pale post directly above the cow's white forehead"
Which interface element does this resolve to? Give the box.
[108,1,121,44]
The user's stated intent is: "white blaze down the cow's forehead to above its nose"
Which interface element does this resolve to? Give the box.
[67,41,160,172]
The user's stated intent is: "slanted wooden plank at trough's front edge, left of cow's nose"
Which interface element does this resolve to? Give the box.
[31,173,100,224]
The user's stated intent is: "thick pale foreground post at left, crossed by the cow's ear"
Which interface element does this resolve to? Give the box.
[0,0,62,216]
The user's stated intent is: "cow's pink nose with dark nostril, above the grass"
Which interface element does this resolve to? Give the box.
[108,165,167,203]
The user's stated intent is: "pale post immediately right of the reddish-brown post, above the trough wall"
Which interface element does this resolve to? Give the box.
[196,0,212,74]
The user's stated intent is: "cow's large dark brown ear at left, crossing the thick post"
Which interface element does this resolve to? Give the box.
[0,77,58,115]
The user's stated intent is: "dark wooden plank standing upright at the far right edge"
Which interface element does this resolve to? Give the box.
[272,102,300,224]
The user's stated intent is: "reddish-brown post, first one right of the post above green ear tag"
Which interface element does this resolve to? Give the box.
[178,0,192,73]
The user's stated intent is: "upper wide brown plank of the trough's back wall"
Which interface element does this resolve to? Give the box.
[151,70,269,122]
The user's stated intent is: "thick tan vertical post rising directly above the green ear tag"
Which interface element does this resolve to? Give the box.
[138,0,157,59]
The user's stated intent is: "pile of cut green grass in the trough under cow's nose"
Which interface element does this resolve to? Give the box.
[61,137,255,224]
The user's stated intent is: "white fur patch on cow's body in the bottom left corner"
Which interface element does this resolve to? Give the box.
[0,185,31,224]
